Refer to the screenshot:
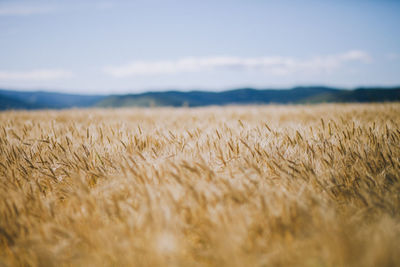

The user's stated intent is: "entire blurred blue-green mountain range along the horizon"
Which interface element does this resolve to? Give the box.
[0,86,400,110]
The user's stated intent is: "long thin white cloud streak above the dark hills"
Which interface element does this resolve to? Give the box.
[104,50,371,78]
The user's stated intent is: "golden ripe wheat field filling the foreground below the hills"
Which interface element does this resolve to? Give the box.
[0,103,400,266]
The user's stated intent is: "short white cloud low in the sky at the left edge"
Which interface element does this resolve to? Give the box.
[0,69,73,81]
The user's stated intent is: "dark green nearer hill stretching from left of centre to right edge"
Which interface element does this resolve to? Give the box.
[96,87,400,107]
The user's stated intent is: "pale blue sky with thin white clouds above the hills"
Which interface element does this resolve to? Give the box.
[0,0,400,94]
